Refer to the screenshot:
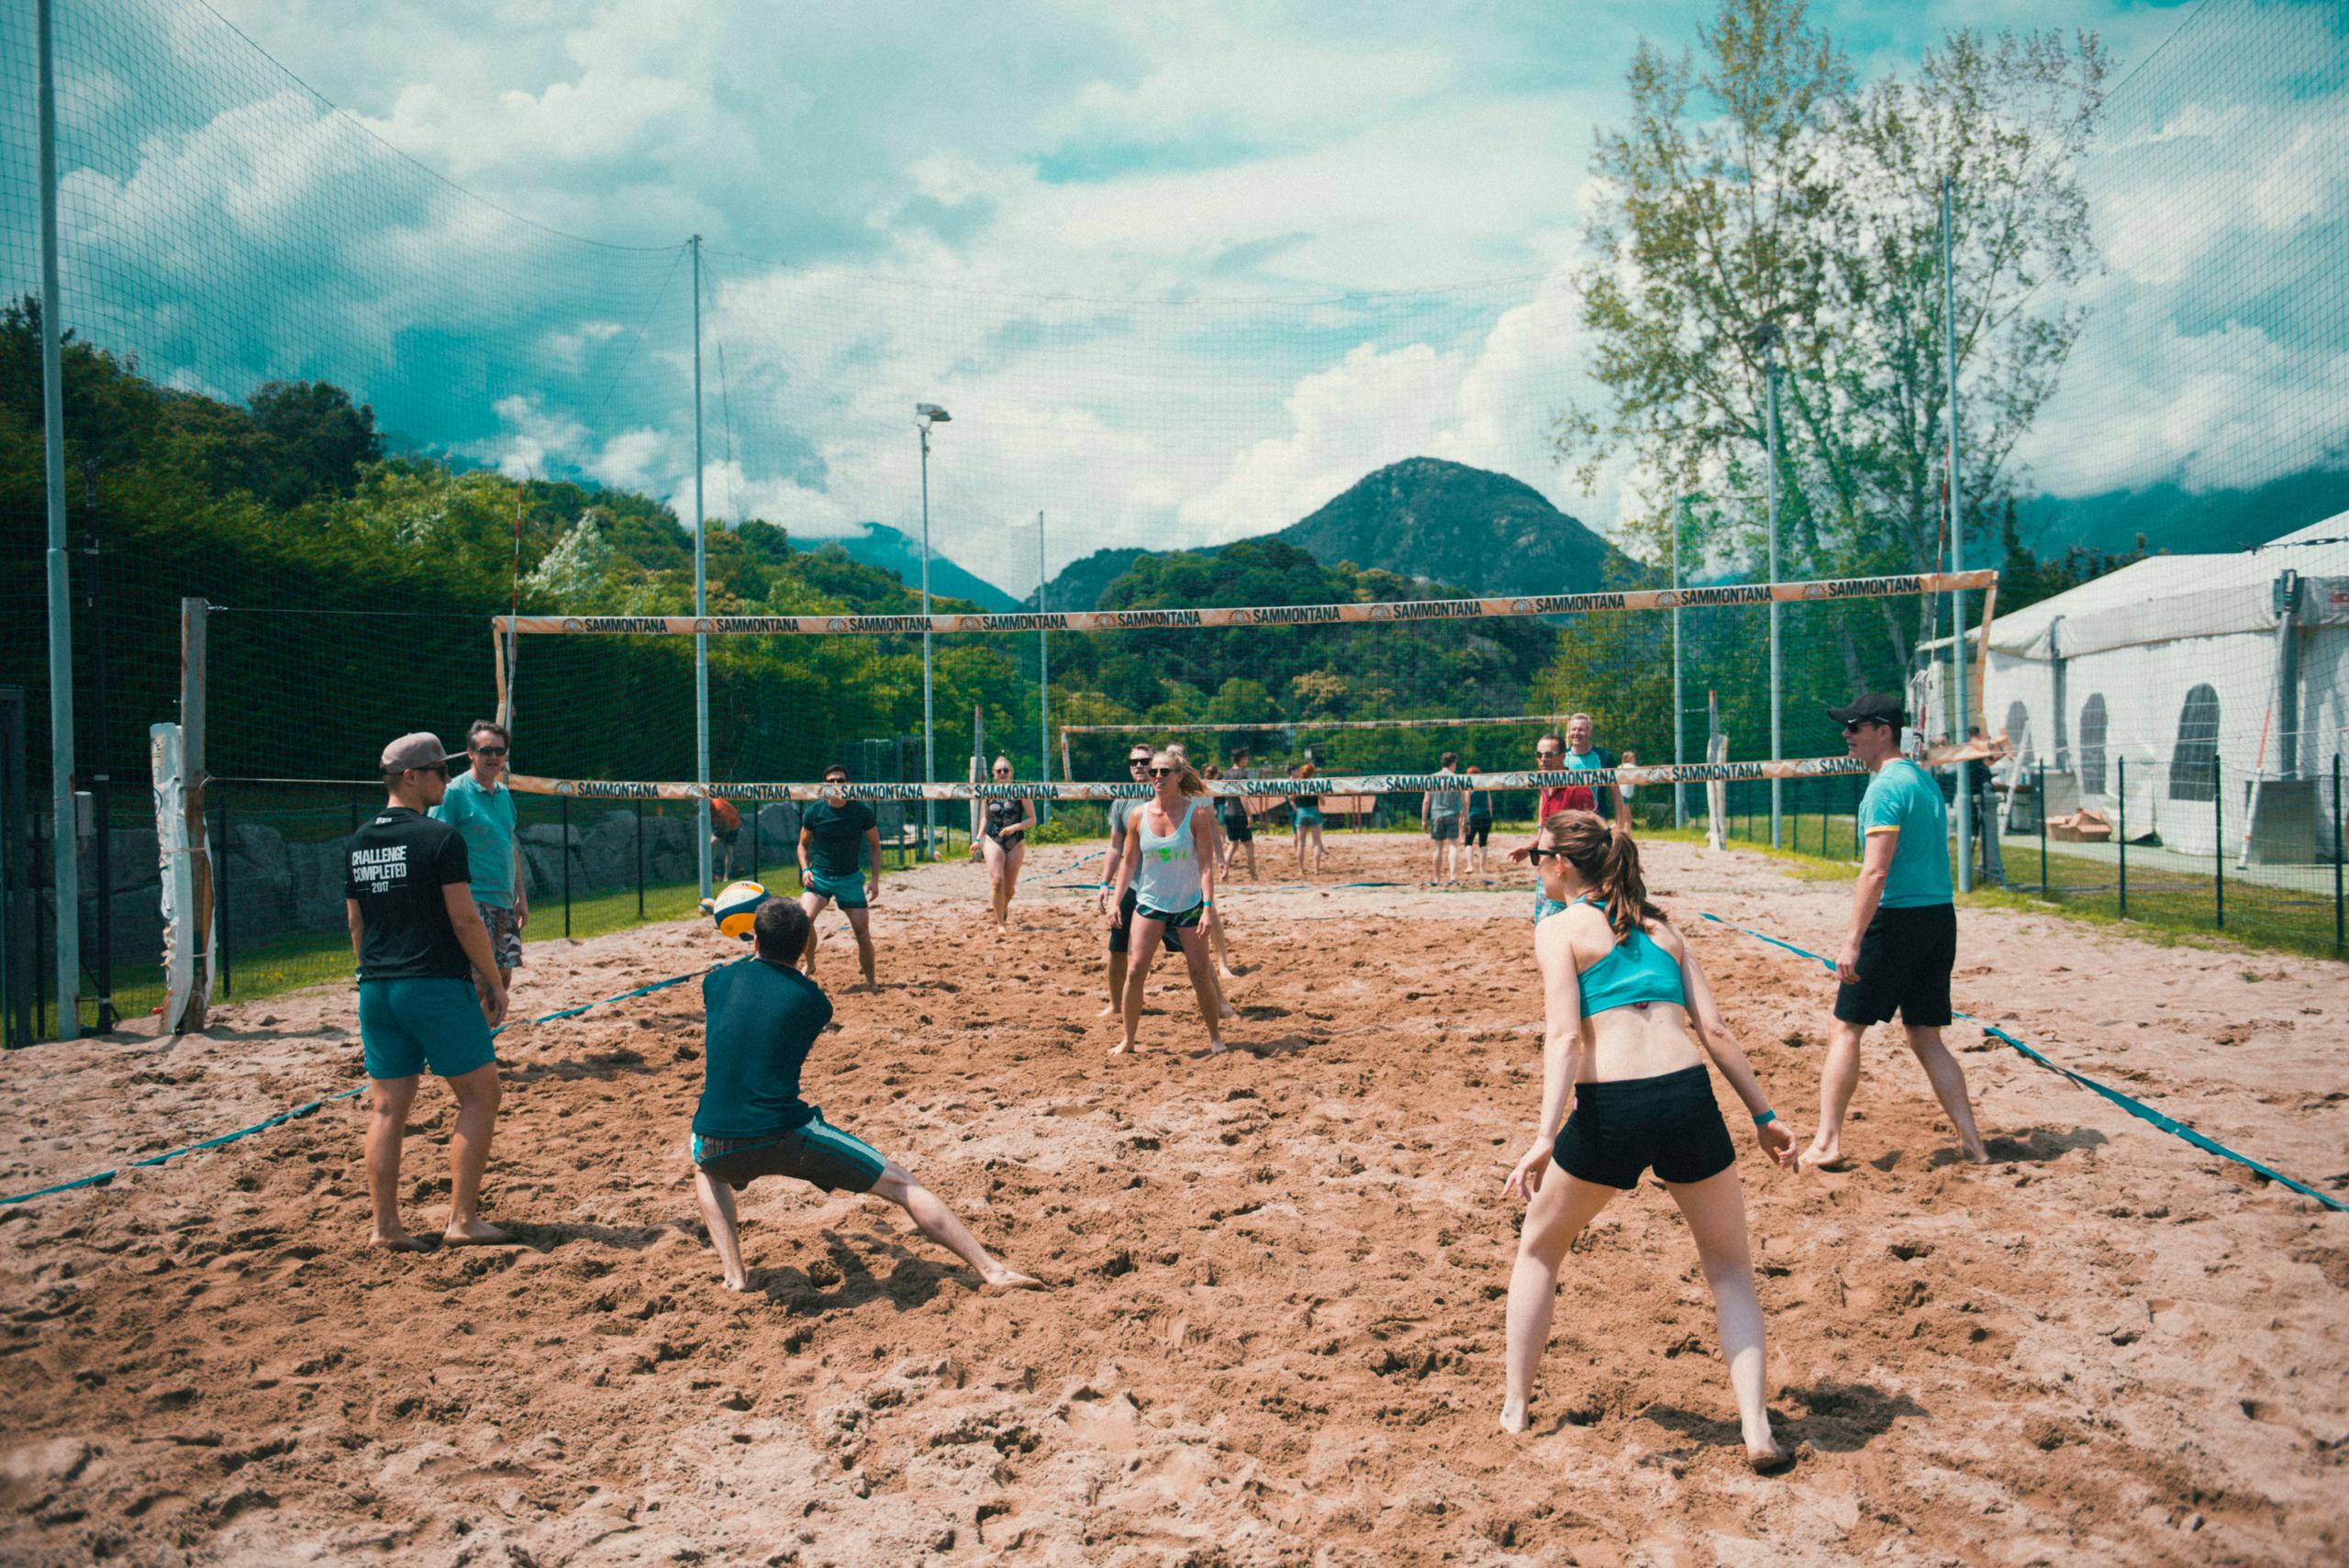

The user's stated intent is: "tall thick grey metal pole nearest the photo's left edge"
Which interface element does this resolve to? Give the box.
[33,0,79,1040]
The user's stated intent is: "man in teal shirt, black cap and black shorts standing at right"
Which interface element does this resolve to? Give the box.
[1802,693,1989,1167]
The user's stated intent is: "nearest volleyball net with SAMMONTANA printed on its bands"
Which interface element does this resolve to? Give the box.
[488,571,1997,800]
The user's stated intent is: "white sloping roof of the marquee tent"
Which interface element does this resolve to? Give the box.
[1989,512,2349,660]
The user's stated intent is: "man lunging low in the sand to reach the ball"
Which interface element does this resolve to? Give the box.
[693,899,1043,1291]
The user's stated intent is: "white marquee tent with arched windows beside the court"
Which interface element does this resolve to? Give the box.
[1983,512,2349,862]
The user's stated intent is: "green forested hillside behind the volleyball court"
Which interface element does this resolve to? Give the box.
[0,306,2111,797]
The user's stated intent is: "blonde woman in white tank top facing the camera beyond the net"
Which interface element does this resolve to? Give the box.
[1107,751,1224,1056]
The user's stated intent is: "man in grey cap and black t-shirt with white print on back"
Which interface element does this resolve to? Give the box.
[343,732,507,1251]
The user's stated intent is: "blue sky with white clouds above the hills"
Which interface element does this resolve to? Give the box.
[9,0,2349,592]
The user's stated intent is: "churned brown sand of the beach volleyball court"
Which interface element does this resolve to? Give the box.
[0,836,2349,1568]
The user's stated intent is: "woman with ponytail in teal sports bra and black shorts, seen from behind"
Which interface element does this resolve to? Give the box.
[1501,810,1795,1472]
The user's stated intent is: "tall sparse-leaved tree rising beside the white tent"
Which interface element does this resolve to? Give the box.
[1555,0,2105,681]
